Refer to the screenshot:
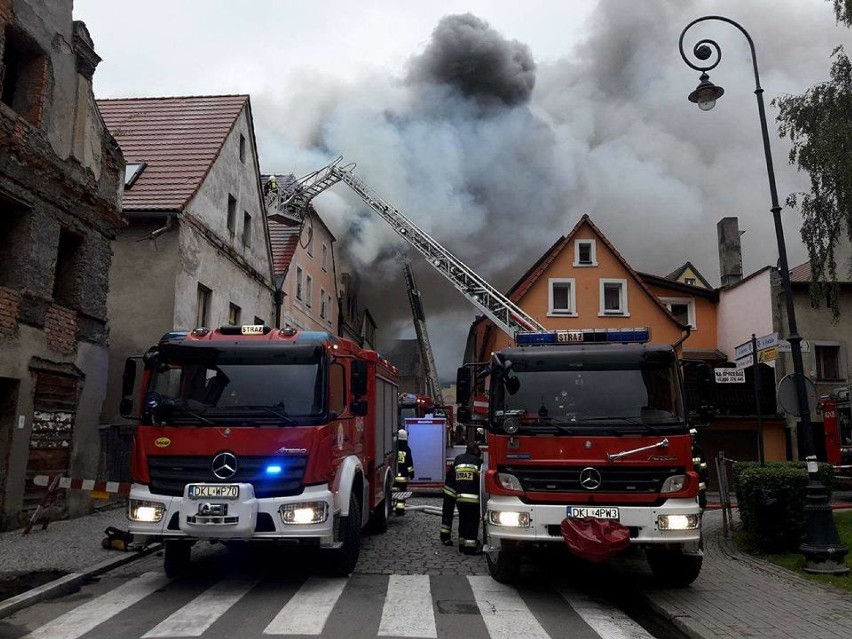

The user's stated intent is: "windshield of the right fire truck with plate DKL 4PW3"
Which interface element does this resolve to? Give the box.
[491,350,686,432]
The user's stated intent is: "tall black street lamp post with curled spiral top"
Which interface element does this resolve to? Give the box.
[678,16,849,575]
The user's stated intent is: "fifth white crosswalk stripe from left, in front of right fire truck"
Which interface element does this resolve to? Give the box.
[467,576,550,639]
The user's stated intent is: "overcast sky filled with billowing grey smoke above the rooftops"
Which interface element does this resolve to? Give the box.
[74,0,852,381]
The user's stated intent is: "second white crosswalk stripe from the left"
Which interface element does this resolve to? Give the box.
[142,579,257,639]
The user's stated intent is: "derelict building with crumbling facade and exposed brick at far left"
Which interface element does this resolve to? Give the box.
[0,0,124,527]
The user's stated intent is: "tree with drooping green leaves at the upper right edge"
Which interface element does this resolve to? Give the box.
[772,0,852,322]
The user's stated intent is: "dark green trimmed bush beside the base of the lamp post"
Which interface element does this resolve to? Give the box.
[733,462,834,552]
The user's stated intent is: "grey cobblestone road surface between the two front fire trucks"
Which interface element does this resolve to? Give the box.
[356,495,488,575]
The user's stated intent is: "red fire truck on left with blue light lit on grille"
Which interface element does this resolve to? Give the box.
[122,326,398,575]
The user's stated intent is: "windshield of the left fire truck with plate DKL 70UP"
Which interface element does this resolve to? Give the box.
[145,347,327,425]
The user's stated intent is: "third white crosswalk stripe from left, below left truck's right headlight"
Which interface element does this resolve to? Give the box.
[263,577,349,635]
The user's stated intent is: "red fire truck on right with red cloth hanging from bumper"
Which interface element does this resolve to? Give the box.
[458,329,703,585]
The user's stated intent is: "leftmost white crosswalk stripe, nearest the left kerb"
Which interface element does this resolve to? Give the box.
[27,572,171,639]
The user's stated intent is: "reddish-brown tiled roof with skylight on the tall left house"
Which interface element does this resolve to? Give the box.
[97,95,248,211]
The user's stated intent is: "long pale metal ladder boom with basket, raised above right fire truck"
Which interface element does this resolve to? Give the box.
[268,158,544,339]
